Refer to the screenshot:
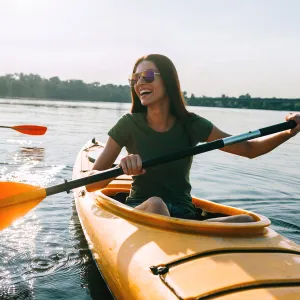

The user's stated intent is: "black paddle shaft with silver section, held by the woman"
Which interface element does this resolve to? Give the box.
[46,120,297,196]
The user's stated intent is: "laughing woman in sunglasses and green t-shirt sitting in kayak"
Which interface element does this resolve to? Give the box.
[89,54,300,222]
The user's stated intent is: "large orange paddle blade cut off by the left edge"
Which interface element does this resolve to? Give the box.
[0,182,46,230]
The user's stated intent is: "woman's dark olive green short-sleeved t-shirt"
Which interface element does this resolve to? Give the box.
[108,113,213,209]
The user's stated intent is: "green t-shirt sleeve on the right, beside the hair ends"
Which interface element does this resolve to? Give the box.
[187,114,214,144]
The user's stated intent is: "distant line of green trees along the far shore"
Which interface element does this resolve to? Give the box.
[0,73,300,111]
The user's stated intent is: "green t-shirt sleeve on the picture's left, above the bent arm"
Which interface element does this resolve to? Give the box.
[108,115,131,147]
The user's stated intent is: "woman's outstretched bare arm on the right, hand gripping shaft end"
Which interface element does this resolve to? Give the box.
[207,113,300,158]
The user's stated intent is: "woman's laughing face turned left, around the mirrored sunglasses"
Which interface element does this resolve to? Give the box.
[134,60,167,106]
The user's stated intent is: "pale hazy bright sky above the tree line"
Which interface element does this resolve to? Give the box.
[0,0,300,98]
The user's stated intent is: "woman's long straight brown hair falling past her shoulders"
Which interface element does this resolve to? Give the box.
[131,54,190,121]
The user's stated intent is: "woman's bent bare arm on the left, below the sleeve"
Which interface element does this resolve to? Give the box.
[86,137,122,192]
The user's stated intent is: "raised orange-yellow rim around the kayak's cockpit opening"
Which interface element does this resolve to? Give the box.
[95,184,271,236]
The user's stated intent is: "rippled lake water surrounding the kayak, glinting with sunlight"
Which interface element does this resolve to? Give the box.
[0,99,300,300]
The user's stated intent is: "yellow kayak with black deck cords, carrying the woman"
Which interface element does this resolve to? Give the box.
[73,140,300,300]
